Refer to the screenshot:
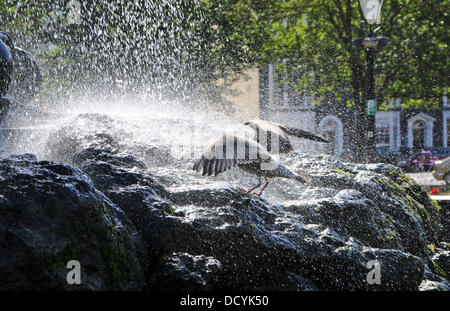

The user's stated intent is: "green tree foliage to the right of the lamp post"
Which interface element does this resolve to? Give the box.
[377,0,450,107]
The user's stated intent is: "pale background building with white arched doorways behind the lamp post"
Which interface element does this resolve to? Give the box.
[259,65,450,157]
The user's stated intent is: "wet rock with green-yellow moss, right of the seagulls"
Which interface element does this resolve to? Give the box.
[287,155,443,257]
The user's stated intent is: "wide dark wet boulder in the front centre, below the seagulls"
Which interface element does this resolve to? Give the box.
[68,145,424,290]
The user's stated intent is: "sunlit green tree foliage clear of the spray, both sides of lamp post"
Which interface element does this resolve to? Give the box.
[202,0,450,106]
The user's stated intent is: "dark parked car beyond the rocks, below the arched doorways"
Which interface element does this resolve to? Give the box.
[397,147,450,173]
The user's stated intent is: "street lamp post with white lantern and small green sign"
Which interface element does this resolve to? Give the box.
[353,0,390,162]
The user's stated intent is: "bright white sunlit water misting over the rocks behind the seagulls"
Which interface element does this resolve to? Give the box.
[1,98,333,204]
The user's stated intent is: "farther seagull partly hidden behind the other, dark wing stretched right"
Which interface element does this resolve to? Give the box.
[244,119,329,154]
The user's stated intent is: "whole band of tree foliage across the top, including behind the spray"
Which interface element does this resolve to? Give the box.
[0,0,449,106]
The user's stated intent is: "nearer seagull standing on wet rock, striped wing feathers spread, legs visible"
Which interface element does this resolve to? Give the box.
[193,134,306,195]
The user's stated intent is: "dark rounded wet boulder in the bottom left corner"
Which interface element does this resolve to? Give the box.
[0,155,145,290]
